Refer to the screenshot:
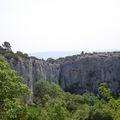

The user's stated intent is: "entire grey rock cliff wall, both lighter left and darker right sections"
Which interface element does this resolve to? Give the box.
[5,52,120,99]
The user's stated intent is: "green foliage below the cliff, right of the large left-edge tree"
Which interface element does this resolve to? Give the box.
[34,80,120,120]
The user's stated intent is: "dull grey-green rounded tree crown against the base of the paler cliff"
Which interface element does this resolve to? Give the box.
[34,80,64,106]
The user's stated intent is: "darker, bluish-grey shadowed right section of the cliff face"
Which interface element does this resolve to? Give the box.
[60,56,120,94]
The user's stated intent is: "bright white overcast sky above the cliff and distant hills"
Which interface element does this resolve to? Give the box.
[0,0,120,53]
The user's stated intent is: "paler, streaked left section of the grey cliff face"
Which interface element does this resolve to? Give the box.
[9,58,60,99]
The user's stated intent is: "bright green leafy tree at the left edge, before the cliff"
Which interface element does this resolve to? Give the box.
[0,57,30,120]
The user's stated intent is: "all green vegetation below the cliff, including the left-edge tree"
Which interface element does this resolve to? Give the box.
[0,58,120,120]
